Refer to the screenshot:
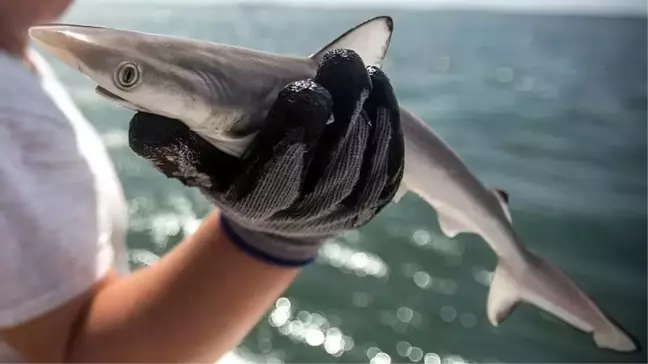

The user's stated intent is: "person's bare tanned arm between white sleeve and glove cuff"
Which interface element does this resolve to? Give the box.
[0,211,298,364]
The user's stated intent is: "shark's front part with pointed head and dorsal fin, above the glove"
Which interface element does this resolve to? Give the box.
[30,16,393,155]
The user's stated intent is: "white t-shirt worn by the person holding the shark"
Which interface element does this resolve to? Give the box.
[0,51,128,364]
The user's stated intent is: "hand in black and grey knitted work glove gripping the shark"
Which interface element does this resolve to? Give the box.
[129,50,404,266]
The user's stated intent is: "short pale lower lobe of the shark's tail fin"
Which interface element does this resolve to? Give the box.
[486,264,520,326]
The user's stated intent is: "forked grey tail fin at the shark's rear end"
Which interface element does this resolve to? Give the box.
[487,252,637,352]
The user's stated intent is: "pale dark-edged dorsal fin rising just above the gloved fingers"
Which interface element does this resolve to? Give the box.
[309,16,394,67]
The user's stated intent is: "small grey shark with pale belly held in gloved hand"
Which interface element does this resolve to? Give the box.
[30,16,638,352]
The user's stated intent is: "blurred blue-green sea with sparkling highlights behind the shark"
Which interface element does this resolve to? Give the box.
[39,0,648,364]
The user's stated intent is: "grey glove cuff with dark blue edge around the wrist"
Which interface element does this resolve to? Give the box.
[220,213,325,267]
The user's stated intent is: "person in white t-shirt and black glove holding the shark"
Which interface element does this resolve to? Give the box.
[0,0,404,364]
